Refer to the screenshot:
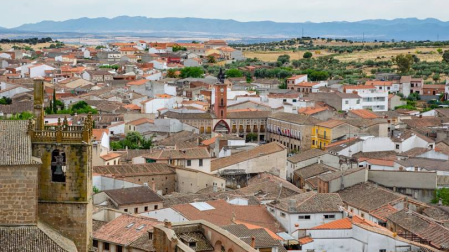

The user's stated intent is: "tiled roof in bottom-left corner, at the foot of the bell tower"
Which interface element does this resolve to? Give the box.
[0,222,78,252]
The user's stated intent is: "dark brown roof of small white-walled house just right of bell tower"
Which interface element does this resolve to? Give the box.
[103,186,162,206]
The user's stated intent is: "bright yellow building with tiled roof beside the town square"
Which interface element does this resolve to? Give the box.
[311,119,349,150]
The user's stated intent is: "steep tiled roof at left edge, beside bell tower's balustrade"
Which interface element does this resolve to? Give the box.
[0,120,35,166]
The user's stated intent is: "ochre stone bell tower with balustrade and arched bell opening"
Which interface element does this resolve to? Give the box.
[28,79,92,252]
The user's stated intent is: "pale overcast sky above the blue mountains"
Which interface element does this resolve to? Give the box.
[0,0,449,28]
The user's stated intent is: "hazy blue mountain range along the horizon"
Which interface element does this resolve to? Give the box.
[0,16,449,40]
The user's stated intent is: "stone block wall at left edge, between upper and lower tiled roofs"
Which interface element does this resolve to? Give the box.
[0,165,39,225]
